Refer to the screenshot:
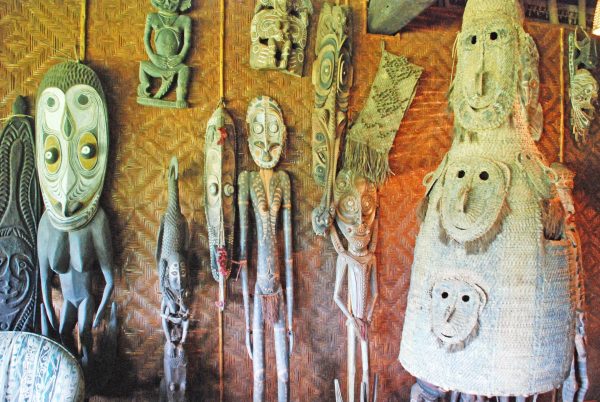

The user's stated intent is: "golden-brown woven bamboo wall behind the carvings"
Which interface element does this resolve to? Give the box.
[0,0,600,401]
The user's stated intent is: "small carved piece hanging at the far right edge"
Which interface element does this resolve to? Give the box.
[569,27,599,143]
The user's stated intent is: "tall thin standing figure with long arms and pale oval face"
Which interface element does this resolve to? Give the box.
[238,96,294,402]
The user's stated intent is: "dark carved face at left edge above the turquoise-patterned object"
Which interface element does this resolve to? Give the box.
[0,233,36,331]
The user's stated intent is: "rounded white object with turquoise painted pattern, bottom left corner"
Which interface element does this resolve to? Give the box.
[0,332,85,402]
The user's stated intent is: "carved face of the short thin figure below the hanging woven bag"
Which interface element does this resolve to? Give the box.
[334,170,377,251]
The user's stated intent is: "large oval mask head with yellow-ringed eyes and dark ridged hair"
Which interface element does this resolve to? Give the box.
[36,62,109,230]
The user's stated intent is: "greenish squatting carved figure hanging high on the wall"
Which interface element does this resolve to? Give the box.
[137,0,192,108]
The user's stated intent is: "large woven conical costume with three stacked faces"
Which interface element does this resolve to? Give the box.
[399,0,575,396]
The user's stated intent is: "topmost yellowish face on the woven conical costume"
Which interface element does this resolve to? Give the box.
[450,17,519,131]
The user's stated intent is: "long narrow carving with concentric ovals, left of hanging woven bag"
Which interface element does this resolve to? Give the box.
[312,2,353,236]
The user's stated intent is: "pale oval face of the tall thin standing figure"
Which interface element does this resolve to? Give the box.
[246,96,287,169]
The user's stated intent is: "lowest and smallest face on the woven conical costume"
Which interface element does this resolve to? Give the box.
[431,279,487,351]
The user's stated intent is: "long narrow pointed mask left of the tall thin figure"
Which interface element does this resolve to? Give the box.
[204,104,236,309]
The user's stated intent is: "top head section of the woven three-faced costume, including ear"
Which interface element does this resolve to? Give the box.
[450,0,543,140]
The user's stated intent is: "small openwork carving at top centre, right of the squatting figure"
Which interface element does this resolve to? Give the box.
[250,0,313,76]
